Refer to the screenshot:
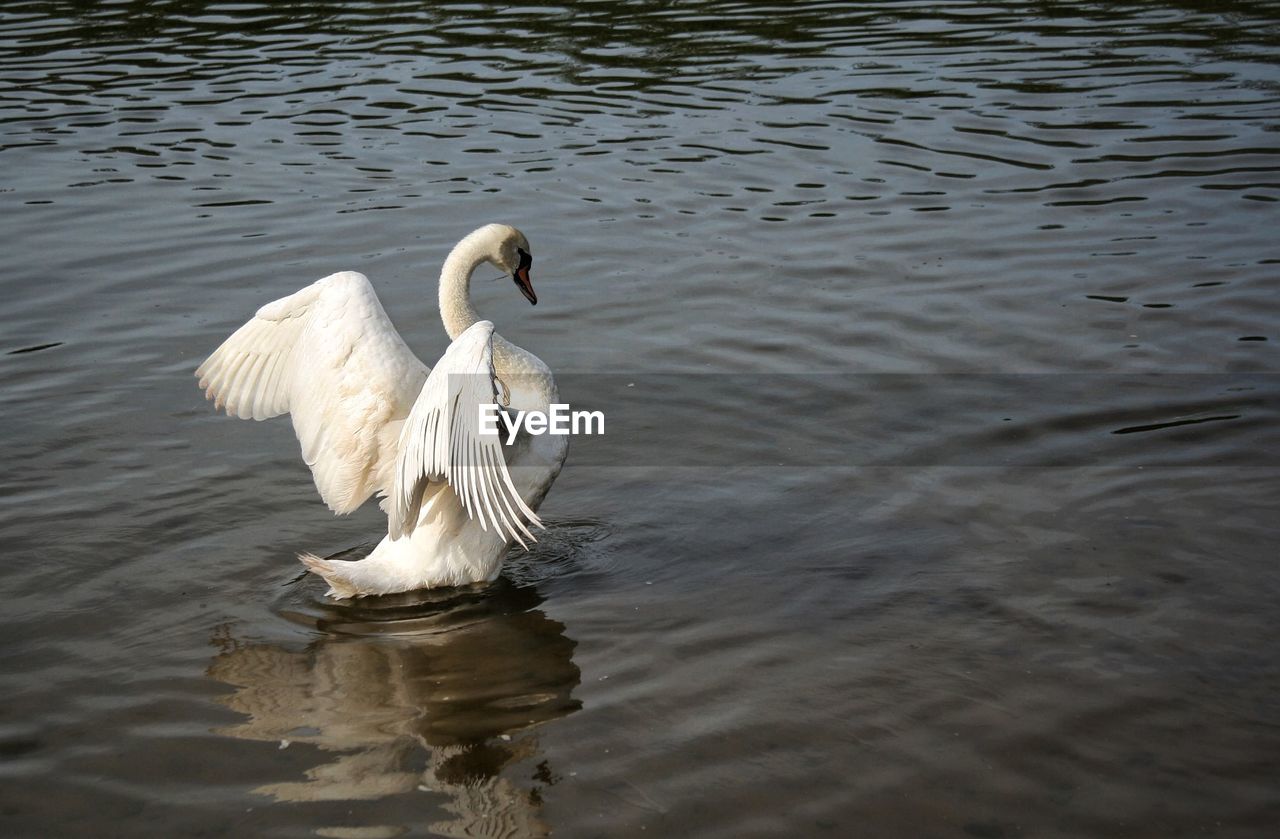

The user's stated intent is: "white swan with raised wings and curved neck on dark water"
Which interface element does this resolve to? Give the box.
[196,224,568,598]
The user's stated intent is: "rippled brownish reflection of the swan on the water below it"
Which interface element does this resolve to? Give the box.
[209,561,581,836]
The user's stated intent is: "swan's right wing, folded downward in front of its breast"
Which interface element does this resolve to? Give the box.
[387,320,543,547]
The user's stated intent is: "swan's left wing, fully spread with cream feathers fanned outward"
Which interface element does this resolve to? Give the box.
[196,272,429,514]
